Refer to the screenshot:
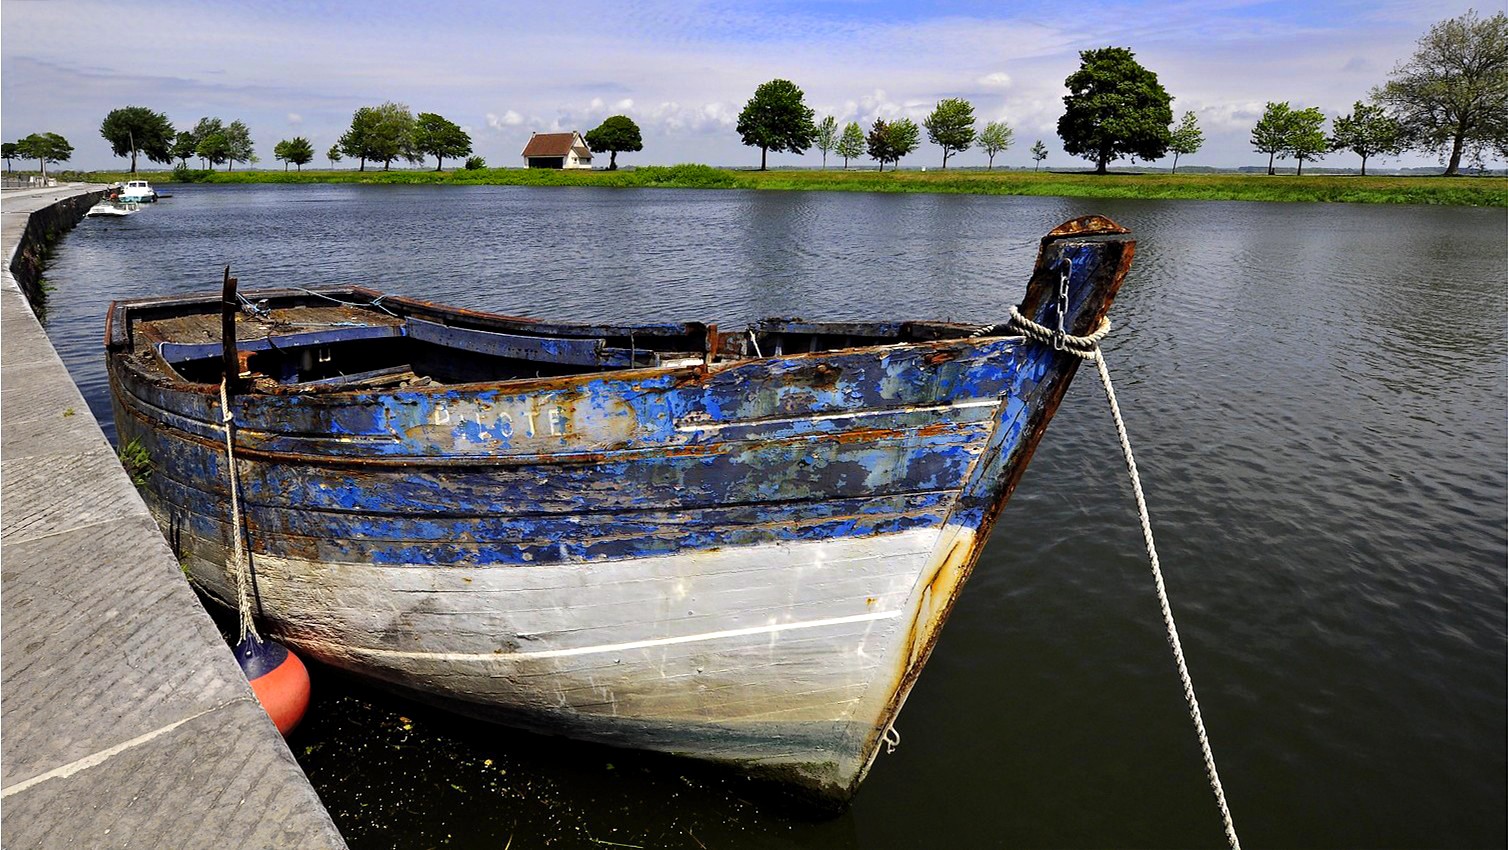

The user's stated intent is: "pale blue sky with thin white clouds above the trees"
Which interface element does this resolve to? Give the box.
[0,0,1503,169]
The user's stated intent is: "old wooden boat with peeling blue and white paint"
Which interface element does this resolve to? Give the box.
[106,217,1134,802]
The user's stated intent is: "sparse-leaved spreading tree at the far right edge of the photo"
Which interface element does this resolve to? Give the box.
[1372,11,1508,175]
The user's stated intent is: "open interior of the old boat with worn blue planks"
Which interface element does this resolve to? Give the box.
[114,288,977,393]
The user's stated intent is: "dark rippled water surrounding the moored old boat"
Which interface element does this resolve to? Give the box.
[47,185,1508,848]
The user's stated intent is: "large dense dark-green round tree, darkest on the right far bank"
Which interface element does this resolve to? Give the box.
[1057,47,1173,175]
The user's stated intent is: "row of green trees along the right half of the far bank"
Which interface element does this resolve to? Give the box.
[736,11,1508,175]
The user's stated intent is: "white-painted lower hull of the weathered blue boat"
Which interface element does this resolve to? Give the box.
[182,526,973,797]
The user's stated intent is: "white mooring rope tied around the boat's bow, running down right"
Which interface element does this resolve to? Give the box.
[1009,307,1241,850]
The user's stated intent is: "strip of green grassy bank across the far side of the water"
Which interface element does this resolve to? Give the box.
[70,166,1508,206]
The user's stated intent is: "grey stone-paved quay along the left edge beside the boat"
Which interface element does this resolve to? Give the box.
[0,184,345,850]
